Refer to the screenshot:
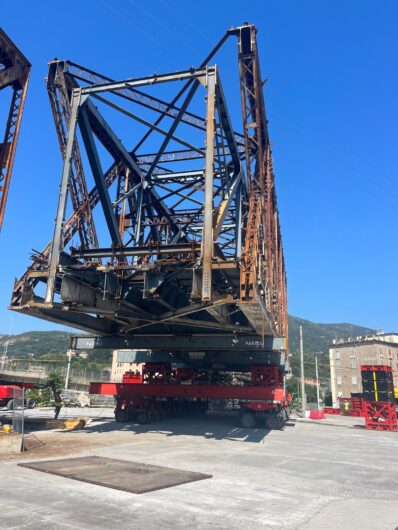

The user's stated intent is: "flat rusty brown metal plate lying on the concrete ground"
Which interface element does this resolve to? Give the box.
[18,456,212,493]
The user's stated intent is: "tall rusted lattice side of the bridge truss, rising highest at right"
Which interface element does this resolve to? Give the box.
[235,25,287,334]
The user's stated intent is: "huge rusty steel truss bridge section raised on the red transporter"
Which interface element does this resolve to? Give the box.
[11,25,287,350]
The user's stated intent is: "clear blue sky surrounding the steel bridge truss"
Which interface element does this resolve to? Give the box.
[0,0,398,333]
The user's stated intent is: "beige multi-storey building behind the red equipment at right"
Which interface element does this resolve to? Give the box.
[329,333,398,407]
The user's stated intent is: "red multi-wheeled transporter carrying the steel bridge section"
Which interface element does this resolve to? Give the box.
[90,363,289,429]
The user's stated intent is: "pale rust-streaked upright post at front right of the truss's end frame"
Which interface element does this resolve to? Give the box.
[202,70,217,302]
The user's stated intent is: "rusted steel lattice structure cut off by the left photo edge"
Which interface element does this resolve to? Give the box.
[0,28,31,230]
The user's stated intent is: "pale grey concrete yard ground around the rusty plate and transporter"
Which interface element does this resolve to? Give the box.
[0,408,398,530]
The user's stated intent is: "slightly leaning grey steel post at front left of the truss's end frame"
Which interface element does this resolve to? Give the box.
[45,89,81,305]
